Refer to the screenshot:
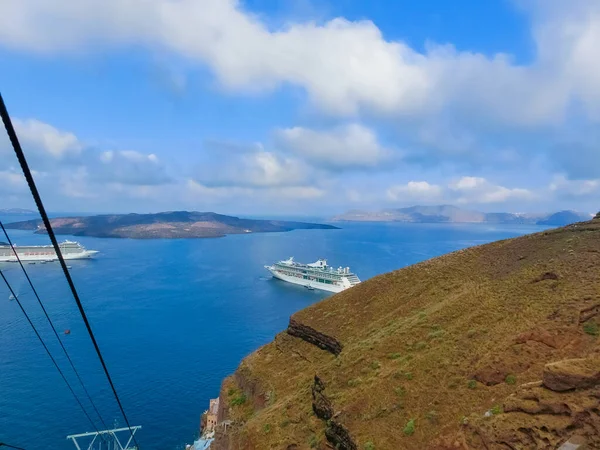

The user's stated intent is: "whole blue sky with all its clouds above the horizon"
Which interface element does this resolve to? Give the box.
[0,0,600,215]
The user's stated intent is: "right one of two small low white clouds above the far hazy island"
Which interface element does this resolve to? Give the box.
[448,177,536,204]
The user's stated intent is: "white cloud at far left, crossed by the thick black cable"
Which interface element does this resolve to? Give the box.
[0,119,172,210]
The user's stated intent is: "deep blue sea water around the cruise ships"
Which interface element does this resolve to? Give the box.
[0,218,542,450]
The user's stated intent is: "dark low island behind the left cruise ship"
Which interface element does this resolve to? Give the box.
[5,211,338,239]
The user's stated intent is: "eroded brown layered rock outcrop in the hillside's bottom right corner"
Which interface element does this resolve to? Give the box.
[462,358,600,450]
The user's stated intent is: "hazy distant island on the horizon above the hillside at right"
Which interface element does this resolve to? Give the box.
[332,205,593,226]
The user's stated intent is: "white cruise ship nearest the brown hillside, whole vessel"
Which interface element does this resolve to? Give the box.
[265,258,360,292]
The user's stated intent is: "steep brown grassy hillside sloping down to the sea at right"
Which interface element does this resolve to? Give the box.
[216,220,600,450]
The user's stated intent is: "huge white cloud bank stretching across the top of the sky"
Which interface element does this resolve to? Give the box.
[0,0,600,125]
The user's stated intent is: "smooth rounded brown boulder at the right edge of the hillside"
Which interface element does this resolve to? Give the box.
[544,358,600,392]
